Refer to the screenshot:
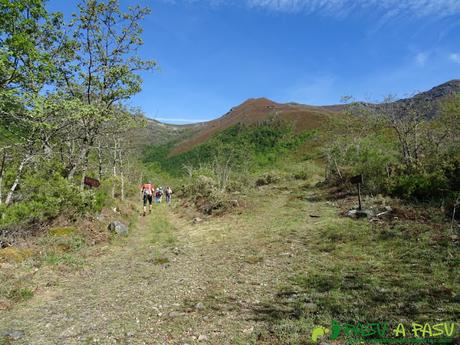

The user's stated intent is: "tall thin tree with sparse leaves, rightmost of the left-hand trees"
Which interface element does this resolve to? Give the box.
[60,0,155,187]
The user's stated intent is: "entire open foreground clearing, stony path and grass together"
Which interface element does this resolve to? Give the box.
[0,163,459,344]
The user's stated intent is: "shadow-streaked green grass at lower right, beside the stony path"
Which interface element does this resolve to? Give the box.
[256,211,459,344]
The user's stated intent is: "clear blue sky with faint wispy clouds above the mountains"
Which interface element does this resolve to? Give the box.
[49,0,460,123]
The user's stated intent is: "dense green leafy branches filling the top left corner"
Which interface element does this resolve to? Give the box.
[0,0,62,92]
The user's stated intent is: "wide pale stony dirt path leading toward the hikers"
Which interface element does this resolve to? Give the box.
[0,191,324,345]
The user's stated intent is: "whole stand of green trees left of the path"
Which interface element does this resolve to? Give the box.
[0,0,155,227]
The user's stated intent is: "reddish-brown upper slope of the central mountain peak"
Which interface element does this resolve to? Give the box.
[171,98,337,155]
